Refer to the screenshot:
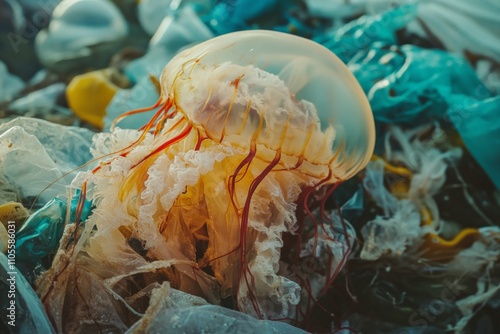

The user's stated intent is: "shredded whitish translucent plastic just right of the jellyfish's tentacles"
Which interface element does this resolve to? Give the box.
[360,126,461,261]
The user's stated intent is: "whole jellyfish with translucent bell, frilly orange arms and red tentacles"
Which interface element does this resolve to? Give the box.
[38,30,375,330]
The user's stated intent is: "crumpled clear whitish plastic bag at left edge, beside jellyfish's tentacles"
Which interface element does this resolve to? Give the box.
[0,117,93,204]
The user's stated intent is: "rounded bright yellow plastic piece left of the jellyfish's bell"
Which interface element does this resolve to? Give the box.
[66,69,126,129]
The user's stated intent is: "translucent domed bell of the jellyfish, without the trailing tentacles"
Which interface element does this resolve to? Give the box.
[161,30,375,181]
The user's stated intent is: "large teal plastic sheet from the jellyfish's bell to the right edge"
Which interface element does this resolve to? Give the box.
[316,5,500,188]
